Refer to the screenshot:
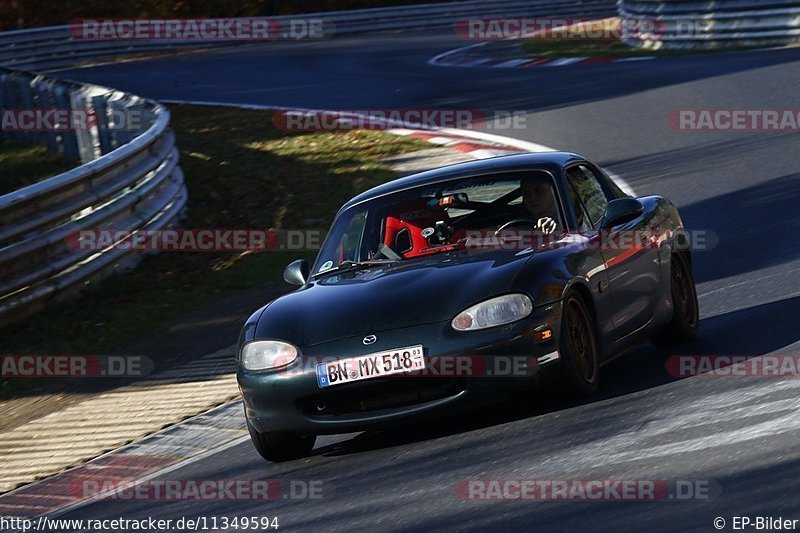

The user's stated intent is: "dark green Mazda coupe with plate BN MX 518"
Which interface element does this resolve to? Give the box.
[237,152,699,461]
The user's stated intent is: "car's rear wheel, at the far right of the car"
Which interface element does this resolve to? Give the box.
[652,253,700,346]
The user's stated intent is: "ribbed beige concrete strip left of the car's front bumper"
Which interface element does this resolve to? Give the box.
[0,346,238,494]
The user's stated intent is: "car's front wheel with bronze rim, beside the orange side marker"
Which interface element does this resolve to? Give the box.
[558,293,600,396]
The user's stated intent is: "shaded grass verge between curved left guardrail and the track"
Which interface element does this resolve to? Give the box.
[0,106,429,354]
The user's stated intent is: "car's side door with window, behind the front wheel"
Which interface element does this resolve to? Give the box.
[566,163,659,338]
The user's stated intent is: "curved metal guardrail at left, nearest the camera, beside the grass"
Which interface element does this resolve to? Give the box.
[0,68,187,322]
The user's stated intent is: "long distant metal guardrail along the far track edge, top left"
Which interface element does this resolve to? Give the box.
[0,0,614,71]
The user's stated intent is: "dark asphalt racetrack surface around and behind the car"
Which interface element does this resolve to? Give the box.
[58,31,800,531]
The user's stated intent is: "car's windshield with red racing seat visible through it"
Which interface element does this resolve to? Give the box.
[312,171,564,274]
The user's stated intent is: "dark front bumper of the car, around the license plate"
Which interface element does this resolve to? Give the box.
[237,302,561,434]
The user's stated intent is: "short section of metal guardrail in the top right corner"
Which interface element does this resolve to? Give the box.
[618,0,800,49]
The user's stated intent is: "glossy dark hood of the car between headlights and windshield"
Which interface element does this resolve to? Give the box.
[256,252,531,347]
